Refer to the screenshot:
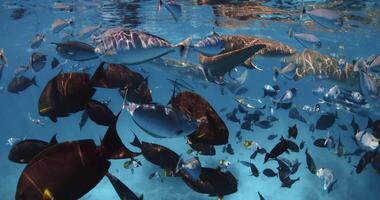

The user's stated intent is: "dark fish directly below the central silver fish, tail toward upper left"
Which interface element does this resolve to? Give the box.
[131,135,179,175]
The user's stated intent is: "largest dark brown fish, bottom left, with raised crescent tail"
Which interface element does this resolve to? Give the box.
[15,114,139,200]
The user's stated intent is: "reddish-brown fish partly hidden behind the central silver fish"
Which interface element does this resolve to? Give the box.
[171,92,229,145]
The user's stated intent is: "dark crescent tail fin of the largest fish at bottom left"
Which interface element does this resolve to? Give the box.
[100,111,139,159]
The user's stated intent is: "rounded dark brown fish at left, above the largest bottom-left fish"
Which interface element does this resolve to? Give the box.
[38,73,96,122]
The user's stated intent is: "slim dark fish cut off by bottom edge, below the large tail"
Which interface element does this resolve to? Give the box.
[106,172,143,200]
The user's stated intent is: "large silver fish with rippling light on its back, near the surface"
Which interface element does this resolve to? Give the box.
[93,27,191,64]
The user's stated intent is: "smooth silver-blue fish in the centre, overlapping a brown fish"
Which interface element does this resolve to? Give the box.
[126,103,198,138]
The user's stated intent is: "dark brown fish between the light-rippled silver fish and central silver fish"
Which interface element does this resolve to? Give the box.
[91,62,152,104]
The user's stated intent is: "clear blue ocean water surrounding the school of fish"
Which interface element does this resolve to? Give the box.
[0,0,380,200]
